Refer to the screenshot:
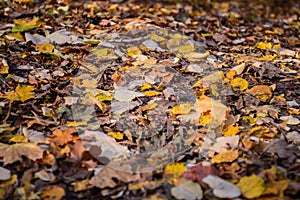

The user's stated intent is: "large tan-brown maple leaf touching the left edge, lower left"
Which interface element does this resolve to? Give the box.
[0,143,44,165]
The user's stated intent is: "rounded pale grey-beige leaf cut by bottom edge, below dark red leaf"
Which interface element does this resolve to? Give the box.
[171,181,203,200]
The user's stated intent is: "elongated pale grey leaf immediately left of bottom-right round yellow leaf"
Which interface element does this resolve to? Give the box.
[202,175,241,198]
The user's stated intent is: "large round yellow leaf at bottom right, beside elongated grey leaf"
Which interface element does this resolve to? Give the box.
[237,174,265,199]
